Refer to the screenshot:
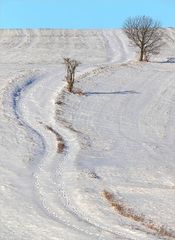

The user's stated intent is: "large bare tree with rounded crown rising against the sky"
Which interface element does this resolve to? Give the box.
[123,16,163,61]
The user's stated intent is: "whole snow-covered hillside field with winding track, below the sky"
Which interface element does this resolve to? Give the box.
[0,28,175,240]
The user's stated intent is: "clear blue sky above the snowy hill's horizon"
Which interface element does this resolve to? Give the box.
[0,0,175,28]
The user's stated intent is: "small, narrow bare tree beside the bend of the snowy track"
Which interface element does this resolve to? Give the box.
[64,58,80,92]
